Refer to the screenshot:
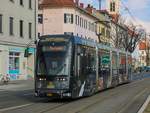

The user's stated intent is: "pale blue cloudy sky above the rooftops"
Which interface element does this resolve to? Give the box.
[80,0,150,33]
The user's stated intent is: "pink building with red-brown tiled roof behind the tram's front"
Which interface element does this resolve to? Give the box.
[38,0,98,41]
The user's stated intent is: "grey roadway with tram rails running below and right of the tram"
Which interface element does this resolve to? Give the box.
[3,77,150,113]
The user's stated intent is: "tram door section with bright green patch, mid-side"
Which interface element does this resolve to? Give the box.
[98,49,110,89]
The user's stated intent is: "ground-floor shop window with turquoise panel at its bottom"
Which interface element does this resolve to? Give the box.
[9,52,20,74]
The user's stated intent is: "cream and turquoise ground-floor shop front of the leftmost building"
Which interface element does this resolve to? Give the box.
[0,46,35,80]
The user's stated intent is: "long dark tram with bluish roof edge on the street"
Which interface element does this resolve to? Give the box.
[35,35,132,98]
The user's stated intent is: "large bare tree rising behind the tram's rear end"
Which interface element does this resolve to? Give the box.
[111,16,145,53]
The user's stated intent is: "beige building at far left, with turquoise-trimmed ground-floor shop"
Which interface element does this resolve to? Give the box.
[0,0,37,79]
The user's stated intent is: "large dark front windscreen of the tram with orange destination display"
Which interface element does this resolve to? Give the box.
[37,43,71,76]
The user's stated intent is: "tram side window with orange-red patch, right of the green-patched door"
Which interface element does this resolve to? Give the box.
[119,55,126,75]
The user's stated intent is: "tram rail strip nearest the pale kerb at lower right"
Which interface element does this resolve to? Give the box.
[117,88,148,113]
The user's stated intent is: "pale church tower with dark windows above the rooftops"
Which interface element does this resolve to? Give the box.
[106,0,120,15]
